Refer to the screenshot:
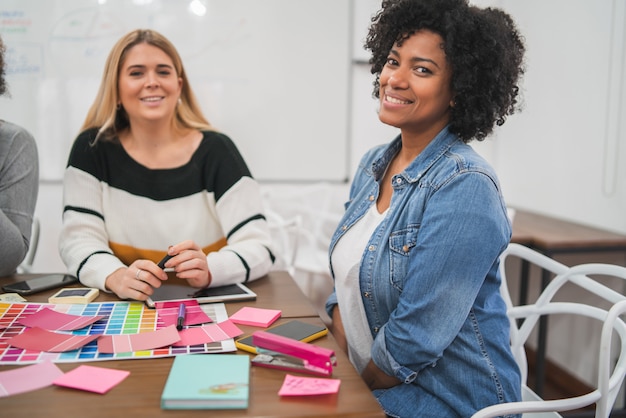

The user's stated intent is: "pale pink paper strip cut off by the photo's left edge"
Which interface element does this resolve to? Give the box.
[0,361,63,397]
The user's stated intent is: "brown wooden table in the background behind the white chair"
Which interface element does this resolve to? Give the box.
[511,210,626,396]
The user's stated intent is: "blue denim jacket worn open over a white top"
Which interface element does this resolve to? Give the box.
[326,128,520,418]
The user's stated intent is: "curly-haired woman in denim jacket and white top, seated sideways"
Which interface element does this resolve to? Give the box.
[327,0,525,418]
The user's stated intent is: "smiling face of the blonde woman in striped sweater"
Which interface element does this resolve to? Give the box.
[118,43,182,125]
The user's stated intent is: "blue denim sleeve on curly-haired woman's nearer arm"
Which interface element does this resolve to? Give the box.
[372,170,511,382]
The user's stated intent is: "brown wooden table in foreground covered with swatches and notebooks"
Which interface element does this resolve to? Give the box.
[0,272,385,418]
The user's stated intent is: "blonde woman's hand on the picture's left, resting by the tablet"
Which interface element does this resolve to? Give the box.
[105,260,167,301]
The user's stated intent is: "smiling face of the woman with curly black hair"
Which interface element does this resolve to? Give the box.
[379,30,453,141]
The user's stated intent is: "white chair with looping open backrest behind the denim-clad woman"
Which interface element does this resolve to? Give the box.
[472,244,626,418]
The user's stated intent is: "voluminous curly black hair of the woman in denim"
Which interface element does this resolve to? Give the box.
[365,0,525,142]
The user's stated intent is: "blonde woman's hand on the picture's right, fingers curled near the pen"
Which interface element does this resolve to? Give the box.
[160,241,211,288]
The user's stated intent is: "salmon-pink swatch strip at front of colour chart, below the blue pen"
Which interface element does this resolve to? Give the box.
[98,325,180,353]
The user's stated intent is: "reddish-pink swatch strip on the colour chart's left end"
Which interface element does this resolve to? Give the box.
[8,327,99,353]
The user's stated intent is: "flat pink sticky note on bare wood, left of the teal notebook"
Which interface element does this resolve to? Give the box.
[52,366,130,394]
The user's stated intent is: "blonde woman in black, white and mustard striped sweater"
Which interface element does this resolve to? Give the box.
[59,30,275,300]
